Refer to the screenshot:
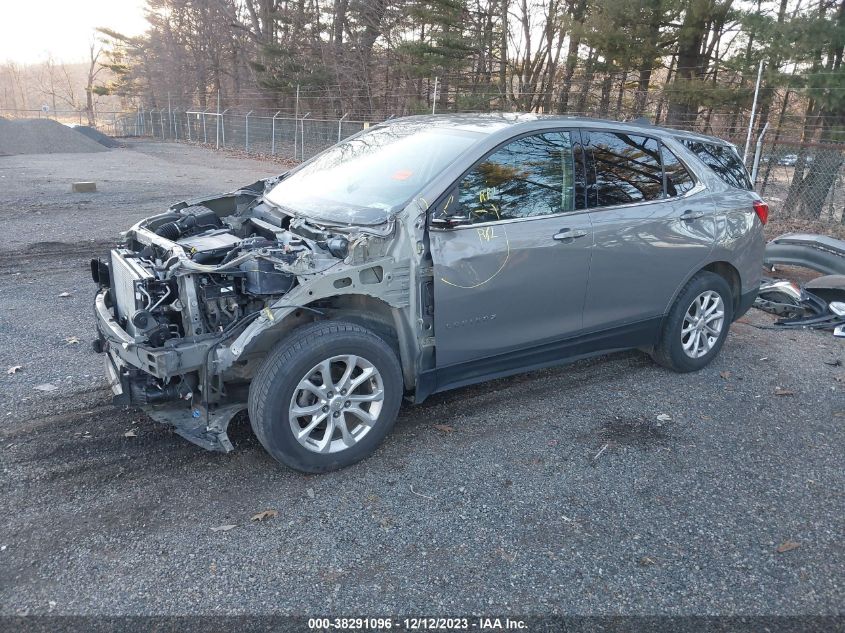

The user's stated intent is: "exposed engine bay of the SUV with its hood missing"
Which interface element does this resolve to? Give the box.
[92,183,392,347]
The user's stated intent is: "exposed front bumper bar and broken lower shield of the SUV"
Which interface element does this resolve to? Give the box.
[95,291,247,453]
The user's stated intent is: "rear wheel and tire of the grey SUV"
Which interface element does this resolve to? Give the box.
[652,271,733,373]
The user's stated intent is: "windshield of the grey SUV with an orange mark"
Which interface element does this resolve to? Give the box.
[266,123,481,224]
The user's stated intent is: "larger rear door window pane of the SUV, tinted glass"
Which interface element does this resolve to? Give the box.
[585,132,663,207]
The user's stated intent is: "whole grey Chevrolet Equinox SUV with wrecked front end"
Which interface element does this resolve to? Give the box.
[92,115,768,472]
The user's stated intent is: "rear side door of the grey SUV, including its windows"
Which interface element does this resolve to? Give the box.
[583,131,716,330]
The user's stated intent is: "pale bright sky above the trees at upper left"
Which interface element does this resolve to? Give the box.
[0,0,146,64]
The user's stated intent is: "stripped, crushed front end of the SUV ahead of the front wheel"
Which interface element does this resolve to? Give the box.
[91,181,400,452]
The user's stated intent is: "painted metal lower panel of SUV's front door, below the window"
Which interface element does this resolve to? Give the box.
[430,213,593,367]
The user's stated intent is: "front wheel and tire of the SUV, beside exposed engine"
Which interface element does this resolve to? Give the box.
[249,321,404,473]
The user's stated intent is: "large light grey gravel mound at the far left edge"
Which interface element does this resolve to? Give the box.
[0,119,106,154]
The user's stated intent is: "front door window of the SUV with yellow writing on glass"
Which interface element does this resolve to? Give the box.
[453,132,583,224]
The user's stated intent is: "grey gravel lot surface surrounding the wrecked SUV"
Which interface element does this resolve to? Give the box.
[0,143,845,615]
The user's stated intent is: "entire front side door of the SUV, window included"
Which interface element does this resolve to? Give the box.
[429,131,593,368]
